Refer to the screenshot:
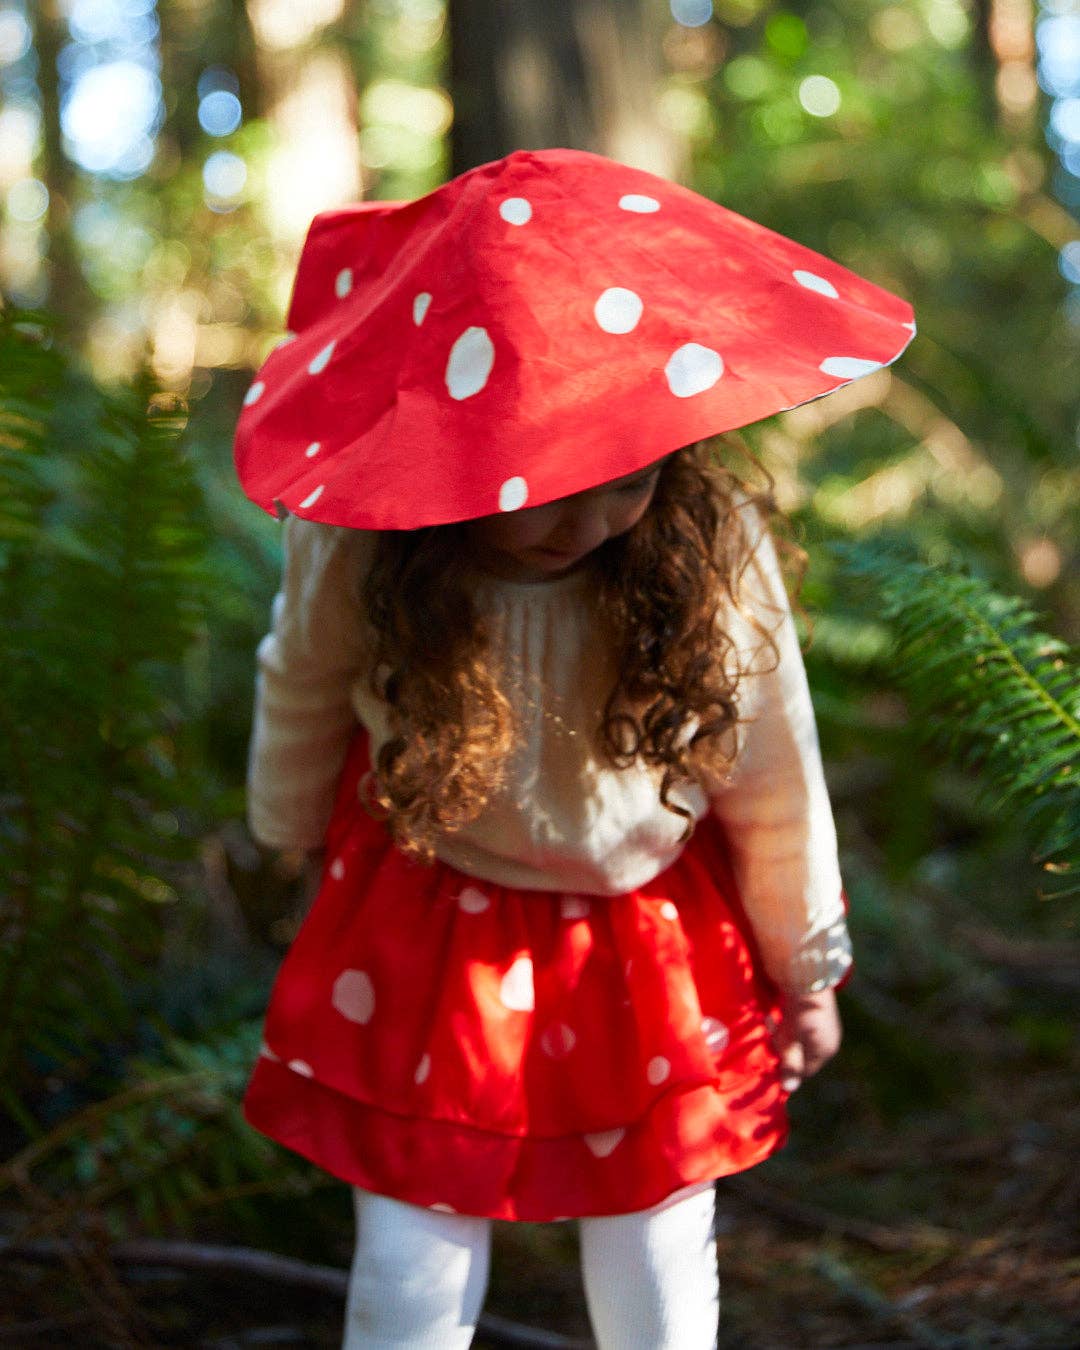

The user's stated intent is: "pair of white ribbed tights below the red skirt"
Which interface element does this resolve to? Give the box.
[343,1185,720,1350]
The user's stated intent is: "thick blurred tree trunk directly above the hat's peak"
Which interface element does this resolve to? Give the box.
[450,0,684,177]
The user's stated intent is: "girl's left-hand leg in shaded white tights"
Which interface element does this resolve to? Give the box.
[343,1187,491,1350]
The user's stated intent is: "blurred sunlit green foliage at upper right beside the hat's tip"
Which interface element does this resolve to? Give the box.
[696,0,1080,564]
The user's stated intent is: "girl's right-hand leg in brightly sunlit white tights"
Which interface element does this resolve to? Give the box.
[581,1184,720,1350]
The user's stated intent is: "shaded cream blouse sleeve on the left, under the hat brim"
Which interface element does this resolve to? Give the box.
[247,516,371,849]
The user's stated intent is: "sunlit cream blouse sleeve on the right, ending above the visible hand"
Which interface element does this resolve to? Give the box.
[711,520,852,994]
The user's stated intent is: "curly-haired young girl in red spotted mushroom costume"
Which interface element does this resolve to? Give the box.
[238,151,914,1350]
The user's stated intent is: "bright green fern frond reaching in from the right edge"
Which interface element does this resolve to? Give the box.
[836,543,1080,894]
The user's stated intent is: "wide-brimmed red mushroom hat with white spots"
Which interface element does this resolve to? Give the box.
[236,150,915,529]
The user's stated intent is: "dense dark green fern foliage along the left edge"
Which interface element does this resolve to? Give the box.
[0,312,213,1112]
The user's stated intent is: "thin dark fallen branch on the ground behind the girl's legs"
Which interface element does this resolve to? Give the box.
[0,1238,594,1350]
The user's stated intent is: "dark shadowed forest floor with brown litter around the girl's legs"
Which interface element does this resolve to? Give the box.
[0,984,1080,1350]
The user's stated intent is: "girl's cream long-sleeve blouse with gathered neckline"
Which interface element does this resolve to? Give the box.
[248,517,851,992]
